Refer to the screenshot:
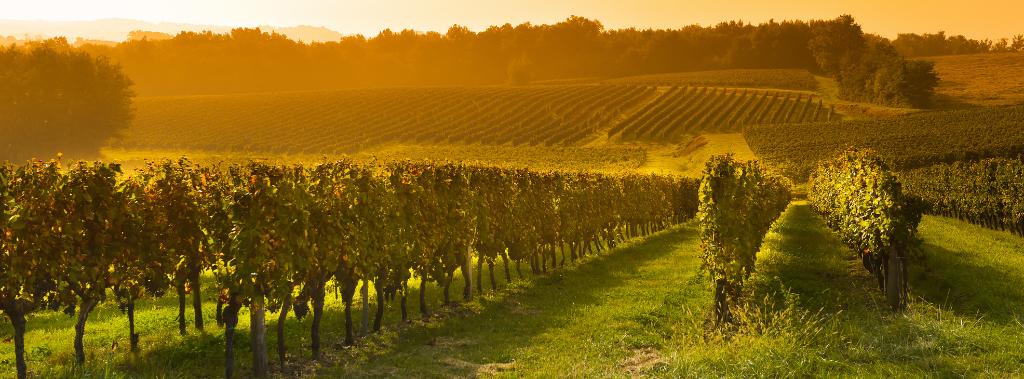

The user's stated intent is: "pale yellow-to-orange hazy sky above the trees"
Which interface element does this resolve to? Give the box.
[8,0,1024,39]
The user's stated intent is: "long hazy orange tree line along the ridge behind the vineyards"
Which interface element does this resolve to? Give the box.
[0,16,929,100]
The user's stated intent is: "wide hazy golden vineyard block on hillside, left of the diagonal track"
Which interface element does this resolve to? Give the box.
[121,85,654,154]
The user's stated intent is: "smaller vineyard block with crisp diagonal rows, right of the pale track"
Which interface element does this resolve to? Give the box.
[608,86,834,141]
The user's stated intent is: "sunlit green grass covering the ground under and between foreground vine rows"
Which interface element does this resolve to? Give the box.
[0,202,1024,378]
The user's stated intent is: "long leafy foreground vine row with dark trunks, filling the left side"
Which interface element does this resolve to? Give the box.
[0,156,697,378]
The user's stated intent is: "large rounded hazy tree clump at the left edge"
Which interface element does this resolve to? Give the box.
[0,37,135,161]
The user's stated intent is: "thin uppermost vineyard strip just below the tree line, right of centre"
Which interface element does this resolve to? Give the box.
[604,70,818,91]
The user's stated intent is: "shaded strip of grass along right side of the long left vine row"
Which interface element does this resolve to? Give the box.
[331,224,710,377]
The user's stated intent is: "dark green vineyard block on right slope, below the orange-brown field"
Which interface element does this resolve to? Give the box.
[744,106,1024,181]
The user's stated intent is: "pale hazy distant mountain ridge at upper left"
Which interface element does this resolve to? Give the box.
[0,18,344,43]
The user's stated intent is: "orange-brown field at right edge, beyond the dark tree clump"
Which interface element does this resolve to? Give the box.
[924,53,1024,108]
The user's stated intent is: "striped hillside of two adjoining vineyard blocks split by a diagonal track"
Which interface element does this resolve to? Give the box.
[112,84,838,155]
